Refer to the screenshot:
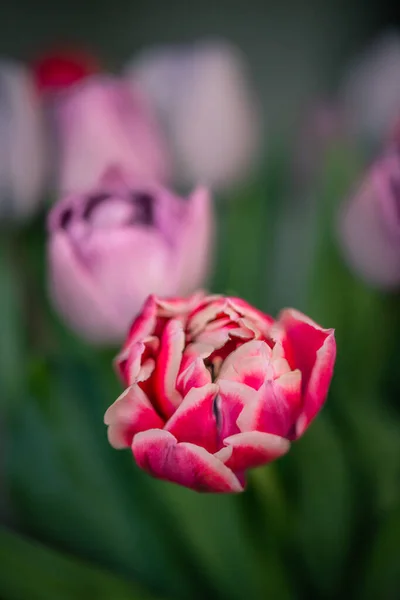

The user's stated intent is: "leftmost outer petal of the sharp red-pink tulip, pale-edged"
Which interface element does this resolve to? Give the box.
[104,385,164,448]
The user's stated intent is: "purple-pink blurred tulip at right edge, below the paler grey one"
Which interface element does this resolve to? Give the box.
[339,150,400,288]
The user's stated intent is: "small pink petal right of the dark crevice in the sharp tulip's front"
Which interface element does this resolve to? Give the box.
[216,380,257,441]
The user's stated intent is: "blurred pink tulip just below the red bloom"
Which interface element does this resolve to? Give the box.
[54,76,168,193]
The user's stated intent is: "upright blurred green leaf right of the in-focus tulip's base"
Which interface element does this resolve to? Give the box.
[288,415,353,598]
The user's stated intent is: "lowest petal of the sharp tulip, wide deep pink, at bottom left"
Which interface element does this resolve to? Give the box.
[132,429,243,493]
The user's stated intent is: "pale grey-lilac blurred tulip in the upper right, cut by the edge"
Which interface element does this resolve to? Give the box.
[340,32,400,148]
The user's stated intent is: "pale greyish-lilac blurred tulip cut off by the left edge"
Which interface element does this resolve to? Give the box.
[0,60,47,219]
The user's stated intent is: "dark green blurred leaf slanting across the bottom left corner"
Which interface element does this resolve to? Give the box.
[0,528,161,600]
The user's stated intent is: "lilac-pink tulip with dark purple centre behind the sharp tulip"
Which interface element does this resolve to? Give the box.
[48,172,213,344]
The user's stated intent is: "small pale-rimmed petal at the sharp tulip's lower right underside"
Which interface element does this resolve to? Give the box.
[215,431,290,473]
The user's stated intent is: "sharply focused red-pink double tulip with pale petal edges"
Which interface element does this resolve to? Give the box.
[104,292,336,492]
